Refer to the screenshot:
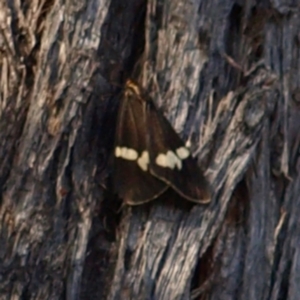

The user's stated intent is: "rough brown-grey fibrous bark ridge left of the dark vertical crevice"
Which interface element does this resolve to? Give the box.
[0,0,109,299]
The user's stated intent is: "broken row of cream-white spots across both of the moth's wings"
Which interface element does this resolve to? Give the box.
[115,147,190,171]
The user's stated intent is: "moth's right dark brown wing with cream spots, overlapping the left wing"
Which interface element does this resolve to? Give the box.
[147,102,211,203]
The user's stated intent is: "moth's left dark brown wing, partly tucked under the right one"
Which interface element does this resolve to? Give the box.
[114,94,168,205]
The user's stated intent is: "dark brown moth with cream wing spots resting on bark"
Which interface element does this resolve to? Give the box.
[114,79,210,205]
